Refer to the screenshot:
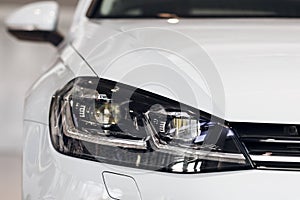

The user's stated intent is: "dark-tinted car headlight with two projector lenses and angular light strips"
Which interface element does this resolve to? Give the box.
[50,77,252,173]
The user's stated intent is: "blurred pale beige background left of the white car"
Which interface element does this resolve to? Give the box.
[0,0,77,200]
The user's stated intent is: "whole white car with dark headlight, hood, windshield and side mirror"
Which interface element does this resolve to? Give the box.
[6,0,300,200]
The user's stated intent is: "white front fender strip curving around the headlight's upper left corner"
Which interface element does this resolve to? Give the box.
[24,47,95,124]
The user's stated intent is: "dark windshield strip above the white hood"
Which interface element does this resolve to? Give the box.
[87,0,300,18]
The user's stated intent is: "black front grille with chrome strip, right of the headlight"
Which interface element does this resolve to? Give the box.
[231,123,300,170]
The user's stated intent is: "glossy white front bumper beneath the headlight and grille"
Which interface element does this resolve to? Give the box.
[23,121,300,200]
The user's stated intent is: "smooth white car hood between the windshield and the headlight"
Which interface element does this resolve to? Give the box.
[72,19,300,124]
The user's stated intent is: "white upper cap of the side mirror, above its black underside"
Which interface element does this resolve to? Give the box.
[6,1,59,31]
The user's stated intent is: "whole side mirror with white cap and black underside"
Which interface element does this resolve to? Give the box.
[5,1,63,46]
